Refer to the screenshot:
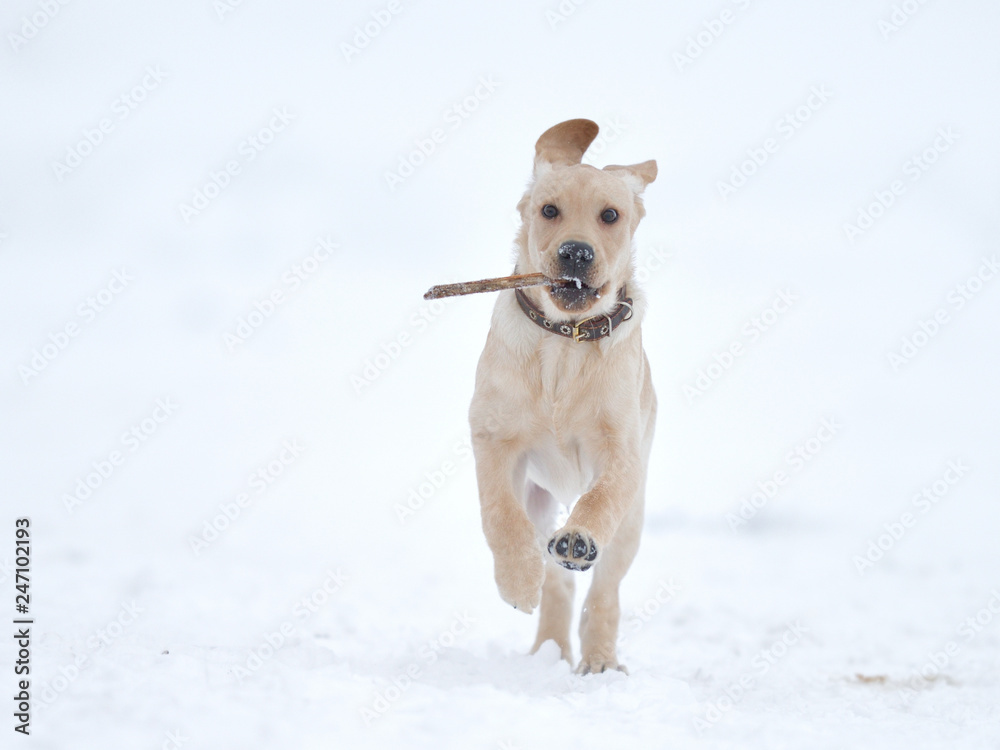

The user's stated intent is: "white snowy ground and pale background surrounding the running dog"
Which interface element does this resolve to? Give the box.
[0,0,1000,750]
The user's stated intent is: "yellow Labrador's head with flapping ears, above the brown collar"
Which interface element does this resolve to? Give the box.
[517,120,656,319]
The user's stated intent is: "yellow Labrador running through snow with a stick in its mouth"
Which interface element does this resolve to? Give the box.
[469,120,656,674]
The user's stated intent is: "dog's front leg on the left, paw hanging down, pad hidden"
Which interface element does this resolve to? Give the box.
[472,435,545,614]
